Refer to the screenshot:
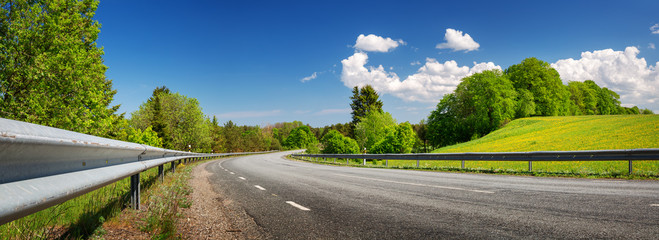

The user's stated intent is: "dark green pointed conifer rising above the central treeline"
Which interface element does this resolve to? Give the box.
[350,85,382,126]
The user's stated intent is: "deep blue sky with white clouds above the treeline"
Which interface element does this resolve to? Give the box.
[95,0,659,127]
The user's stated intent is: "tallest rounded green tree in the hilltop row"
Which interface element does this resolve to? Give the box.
[505,57,569,117]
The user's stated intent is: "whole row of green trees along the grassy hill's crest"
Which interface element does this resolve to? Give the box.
[426,58,652,147]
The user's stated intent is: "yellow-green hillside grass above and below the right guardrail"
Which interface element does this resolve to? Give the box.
[296,115,659,179]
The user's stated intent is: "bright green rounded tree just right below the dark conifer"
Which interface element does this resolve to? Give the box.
[355,111,396,150]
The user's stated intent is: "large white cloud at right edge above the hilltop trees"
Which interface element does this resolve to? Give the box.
[551,47,659,109]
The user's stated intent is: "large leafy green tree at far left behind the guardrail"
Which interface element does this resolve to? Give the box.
[0,0,121,137]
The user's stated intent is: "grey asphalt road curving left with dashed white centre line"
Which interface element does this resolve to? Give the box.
[206,152,659,239]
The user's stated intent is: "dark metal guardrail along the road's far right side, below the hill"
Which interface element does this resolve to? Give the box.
[292,148,659,174]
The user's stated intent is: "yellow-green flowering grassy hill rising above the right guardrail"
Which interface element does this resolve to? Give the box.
[435,115,659,153]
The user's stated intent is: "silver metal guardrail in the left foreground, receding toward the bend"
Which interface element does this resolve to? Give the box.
[0,118,268,225]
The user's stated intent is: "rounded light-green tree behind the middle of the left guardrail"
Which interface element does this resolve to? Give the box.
[130,89,212,152]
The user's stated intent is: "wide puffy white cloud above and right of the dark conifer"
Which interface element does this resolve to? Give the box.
[341,52,501,103]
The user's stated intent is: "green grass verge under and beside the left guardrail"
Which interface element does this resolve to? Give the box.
[0,158,205,239]
